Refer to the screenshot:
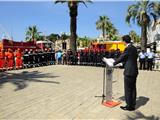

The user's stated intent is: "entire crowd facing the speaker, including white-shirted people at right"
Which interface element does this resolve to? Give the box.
[0,46,159,71]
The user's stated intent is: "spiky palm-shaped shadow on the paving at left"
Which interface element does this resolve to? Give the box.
[0,71,60,91]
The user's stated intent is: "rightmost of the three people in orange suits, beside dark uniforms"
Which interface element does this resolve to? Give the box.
[15,48,22,69]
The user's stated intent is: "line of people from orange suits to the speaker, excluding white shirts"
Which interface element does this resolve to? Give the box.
[0,49,120,71]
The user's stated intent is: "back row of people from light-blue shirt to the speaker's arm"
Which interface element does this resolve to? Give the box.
[55,49,121,66]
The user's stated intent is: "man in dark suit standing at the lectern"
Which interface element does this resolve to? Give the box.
[113,35,138,111]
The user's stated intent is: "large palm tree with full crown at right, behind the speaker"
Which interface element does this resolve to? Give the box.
[126,0,160,50]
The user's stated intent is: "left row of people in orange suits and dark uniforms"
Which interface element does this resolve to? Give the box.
[0,49,55,71]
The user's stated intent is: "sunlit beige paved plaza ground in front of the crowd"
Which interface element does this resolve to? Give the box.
[0,65,160,120]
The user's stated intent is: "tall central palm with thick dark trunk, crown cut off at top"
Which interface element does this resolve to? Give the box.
[55,0,91,51]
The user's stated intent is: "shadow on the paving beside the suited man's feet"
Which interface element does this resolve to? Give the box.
[119,96,149,109]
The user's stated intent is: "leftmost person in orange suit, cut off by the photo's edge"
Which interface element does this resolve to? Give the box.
[0,49,5,71]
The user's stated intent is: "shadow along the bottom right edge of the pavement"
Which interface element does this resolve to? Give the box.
[126,111,160,120]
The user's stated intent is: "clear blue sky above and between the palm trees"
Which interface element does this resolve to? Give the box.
[0,0,140,41]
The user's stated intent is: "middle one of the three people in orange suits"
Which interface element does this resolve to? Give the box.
[6,48,14,70]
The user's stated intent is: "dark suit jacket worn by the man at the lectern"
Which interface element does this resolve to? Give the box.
[114,44,138,77]
